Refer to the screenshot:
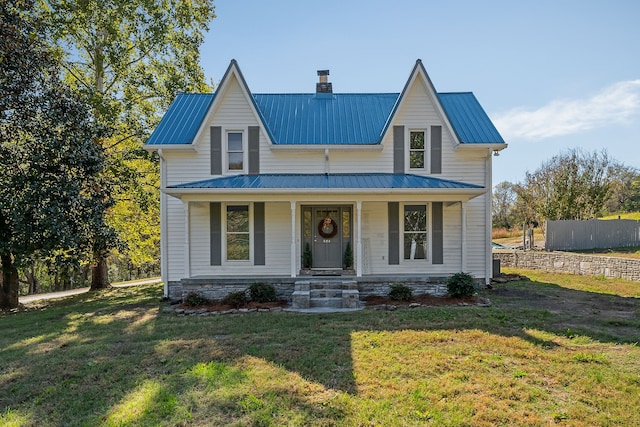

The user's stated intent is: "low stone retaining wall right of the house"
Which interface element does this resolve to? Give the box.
[493,250,640,281]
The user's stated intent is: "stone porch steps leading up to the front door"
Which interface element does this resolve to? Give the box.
[291,279,360,309]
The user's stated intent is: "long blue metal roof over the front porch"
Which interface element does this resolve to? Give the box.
[169,173,484,190]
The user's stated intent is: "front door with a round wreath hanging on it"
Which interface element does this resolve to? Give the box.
[311,207,342,268]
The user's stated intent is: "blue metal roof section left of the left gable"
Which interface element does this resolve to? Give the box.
[147,93,215,145]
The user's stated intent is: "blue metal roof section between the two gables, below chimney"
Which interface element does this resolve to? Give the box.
[253,93,398,145]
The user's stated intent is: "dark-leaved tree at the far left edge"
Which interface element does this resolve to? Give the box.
[0,0,115,308]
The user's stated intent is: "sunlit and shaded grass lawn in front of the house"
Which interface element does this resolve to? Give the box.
[0,278,640,426]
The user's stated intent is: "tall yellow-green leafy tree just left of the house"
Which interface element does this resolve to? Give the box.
[39,0,215,288]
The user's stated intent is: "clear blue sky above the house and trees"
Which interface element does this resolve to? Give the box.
[201,0,640,185]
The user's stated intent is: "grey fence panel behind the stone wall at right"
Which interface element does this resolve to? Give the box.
[544,219,640,251]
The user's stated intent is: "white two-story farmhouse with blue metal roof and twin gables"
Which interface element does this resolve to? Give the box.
[146,60,507,306]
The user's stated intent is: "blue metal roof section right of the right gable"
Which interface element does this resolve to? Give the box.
[438,92,504,144]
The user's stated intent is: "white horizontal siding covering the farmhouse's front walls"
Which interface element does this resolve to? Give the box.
[163,65,491,281]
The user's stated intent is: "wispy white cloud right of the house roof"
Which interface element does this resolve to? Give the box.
[493,80,640,141]
